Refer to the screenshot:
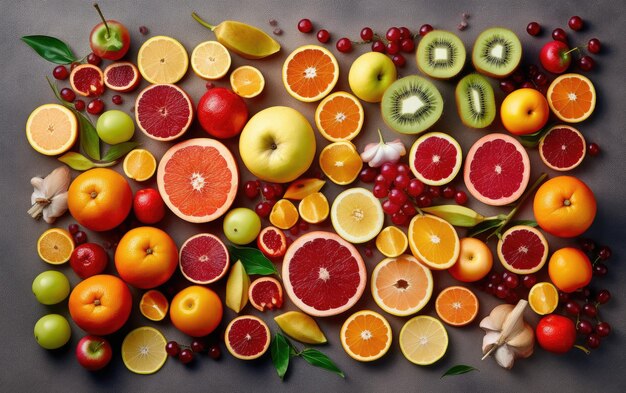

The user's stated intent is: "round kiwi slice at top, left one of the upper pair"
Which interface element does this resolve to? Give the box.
[415,30,466,79]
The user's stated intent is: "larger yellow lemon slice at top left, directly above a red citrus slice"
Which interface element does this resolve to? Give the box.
[137,35,189,84]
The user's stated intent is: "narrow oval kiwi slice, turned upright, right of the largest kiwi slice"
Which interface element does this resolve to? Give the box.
[455,74,496,128]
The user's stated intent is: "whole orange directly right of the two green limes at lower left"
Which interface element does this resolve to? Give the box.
[68,274,133,336]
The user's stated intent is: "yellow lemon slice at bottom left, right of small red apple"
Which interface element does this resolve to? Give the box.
[122,326,167,374]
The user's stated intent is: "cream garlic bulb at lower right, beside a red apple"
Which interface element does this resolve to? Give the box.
[480,300,535,369]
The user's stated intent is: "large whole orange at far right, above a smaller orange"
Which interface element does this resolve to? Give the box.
[533,176,596,237]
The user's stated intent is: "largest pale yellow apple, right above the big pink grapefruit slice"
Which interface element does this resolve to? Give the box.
[239,106,315,183]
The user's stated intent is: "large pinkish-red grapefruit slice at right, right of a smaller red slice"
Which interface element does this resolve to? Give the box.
[463,134,530,206]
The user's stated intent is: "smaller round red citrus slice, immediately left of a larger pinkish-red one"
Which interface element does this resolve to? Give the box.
[409,132,463,186]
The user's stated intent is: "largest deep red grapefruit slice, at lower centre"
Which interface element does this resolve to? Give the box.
[282,231,367,317]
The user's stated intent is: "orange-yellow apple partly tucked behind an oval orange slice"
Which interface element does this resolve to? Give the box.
[448,237,493,282]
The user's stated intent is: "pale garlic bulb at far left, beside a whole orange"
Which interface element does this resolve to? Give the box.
[28,166,70,224]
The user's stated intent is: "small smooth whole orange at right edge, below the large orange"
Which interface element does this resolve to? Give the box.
[548,247,593,293]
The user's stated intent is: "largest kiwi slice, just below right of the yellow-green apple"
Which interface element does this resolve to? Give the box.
[380,75,443,134]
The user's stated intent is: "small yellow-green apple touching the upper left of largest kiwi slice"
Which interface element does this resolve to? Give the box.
[348,52,398,102]
